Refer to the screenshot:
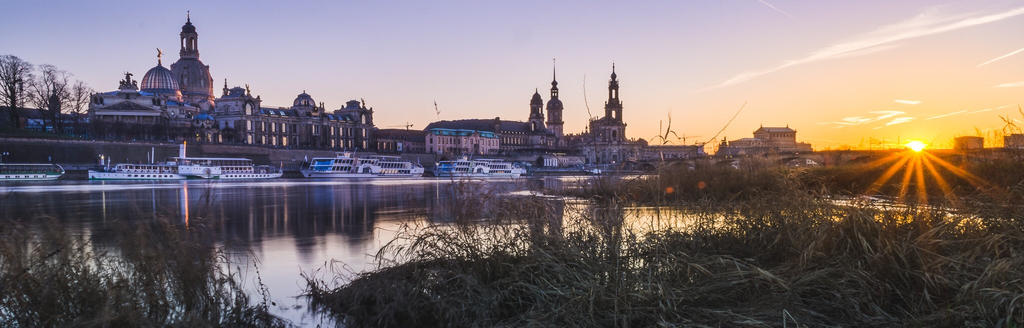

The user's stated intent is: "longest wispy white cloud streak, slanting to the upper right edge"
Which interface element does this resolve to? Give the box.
[703,7,1024,90]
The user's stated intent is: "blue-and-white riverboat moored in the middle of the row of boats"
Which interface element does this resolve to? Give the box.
[299,153,423,178]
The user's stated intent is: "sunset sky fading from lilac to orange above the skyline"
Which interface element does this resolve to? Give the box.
[0,0,1024,152]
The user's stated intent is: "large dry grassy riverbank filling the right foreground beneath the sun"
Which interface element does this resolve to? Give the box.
[307,157,1024,327]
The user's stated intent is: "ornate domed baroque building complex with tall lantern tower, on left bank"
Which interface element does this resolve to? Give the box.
[89,15,375,151]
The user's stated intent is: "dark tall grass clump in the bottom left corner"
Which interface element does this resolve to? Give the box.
[0,220,285,327]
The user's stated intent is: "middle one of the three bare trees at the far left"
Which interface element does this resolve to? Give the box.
[29,65,71,133]
